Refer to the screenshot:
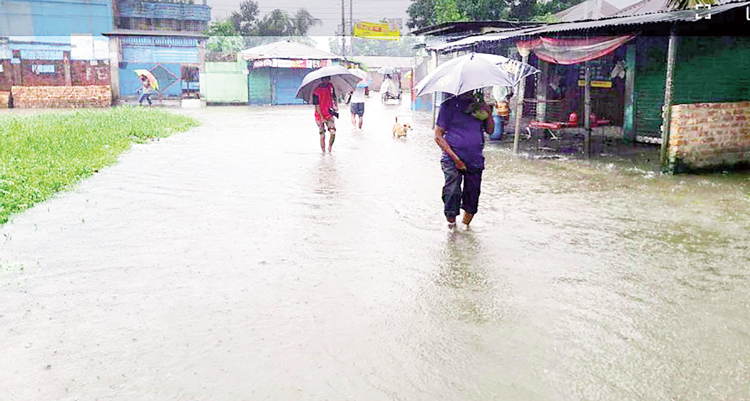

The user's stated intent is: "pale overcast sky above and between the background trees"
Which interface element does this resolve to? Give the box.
[207,0,411,36]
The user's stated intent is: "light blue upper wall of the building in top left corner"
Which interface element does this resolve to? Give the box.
[0,0,113,36]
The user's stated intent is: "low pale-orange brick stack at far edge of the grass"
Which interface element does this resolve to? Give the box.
[12,85,112,109]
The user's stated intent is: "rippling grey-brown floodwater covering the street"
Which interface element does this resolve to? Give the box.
[0,99,750,400]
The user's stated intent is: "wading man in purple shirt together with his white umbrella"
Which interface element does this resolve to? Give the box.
[416,53,538,228]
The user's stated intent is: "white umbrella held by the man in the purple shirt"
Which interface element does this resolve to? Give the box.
[415,53,539,96]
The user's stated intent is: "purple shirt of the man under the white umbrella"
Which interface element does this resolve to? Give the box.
[436,97,484,169]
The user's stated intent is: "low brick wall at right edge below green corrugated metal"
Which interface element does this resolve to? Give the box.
[669,102,750,172]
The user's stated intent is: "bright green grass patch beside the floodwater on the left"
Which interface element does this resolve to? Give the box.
[0,107,198,225]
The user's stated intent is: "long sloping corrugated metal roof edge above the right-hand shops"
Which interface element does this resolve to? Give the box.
[429,1,750,51]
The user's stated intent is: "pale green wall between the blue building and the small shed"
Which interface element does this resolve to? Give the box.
[201,60,248,103]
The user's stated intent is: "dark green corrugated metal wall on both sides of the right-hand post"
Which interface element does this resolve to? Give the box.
[635,36,750,136]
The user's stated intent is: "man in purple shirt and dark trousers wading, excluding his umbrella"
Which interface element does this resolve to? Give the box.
[435,92,495,228]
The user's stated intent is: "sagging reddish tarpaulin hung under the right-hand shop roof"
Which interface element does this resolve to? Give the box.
[516,35,636,65]
